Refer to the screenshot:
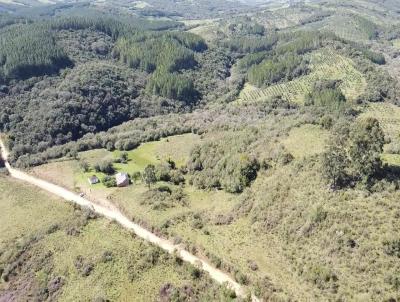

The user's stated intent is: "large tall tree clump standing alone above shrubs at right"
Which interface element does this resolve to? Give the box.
[322,118,385,188]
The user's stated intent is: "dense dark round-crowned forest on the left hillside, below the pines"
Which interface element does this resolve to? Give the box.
[0,62,141,155]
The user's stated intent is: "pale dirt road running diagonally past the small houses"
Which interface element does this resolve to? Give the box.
[0,138,259,302]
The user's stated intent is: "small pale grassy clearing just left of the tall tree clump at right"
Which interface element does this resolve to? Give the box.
[283,124,329,158]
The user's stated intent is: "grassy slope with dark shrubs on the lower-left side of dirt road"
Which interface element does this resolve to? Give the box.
[0,176,227,301]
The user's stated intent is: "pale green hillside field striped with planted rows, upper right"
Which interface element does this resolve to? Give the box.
[239,48,366,104]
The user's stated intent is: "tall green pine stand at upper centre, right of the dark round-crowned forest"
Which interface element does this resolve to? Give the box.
[114,32,207,105]
